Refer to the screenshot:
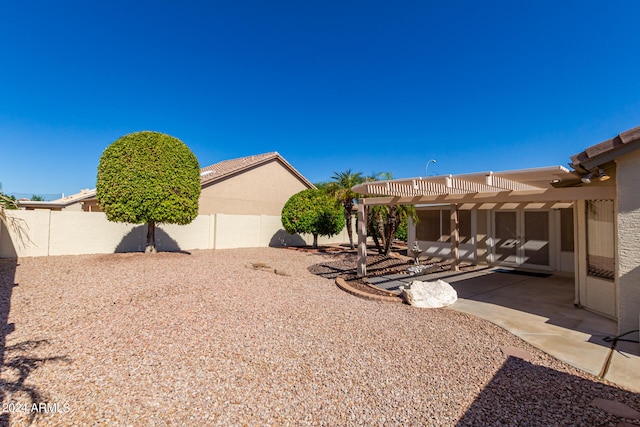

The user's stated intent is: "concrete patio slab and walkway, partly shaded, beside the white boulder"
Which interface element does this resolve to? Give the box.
[368,268,640,391]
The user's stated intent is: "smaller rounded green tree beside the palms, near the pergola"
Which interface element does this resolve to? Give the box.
[282,188,345,248]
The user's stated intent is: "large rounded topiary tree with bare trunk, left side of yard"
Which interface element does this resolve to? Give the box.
[96,131,200,252]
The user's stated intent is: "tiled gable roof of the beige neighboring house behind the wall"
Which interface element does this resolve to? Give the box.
[200,151,314,188]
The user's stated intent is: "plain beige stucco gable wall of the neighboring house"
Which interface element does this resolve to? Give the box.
[199,159,308,216]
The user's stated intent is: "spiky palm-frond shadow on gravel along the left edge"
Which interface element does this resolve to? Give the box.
[0,259,70,427]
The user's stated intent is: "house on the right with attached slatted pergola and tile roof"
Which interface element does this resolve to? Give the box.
[353,127,640,338]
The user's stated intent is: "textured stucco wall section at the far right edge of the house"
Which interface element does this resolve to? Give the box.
[616,151,640,336]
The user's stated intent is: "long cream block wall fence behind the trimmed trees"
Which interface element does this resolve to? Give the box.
[0,210,357,258]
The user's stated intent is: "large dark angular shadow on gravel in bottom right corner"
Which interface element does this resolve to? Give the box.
[457,356,640,427]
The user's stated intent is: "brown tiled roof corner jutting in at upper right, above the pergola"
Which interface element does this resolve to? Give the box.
[570,126,640,173]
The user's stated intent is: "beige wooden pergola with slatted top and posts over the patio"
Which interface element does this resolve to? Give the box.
[353,166,615,276]
